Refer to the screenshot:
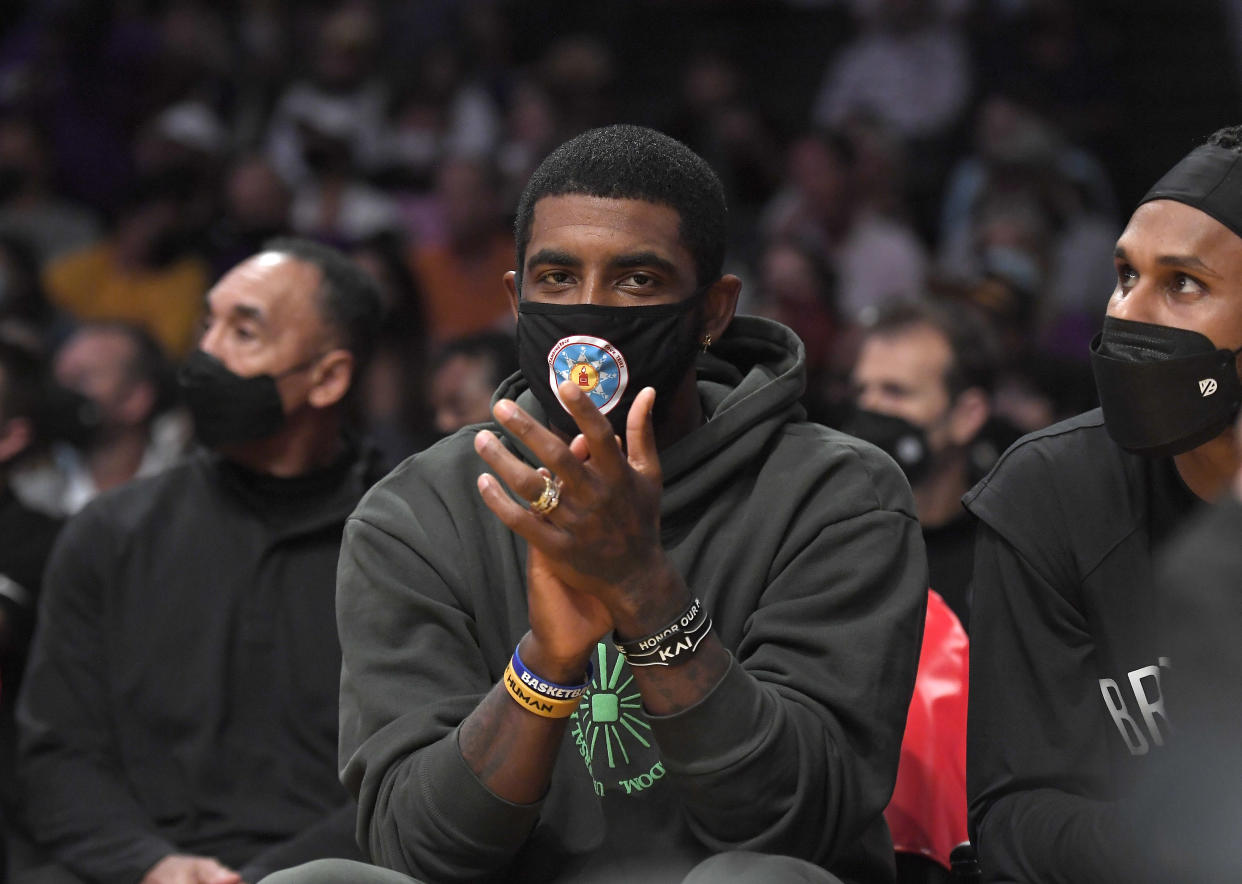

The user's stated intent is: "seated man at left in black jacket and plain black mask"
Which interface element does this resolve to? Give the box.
[16,234,380,884]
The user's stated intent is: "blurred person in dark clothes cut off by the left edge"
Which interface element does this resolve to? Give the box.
[0,334,61,809]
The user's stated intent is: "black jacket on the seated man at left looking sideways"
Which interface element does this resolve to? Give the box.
[19,454,370,884]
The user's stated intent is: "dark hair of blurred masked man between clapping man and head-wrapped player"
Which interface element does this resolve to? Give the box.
[863,298,1000,400]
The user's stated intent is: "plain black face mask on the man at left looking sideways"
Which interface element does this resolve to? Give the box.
[176,350,314,448]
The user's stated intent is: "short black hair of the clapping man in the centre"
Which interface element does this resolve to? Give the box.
[513,125,728,288]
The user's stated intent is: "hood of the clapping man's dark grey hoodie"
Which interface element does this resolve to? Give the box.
[493,315,806,521]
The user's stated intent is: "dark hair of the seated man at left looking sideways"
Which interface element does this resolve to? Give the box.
[263,236,384,369]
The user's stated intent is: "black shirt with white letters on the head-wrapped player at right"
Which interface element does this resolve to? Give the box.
[964,410,1196,884]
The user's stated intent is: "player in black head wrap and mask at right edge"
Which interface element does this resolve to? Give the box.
[964,127,1242,884]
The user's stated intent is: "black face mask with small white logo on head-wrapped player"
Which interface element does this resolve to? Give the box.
[1090,317,1242,457]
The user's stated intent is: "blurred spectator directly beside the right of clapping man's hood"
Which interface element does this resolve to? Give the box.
[754,240,857,426]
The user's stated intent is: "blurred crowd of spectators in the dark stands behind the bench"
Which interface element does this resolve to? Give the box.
[0,0,1227,476]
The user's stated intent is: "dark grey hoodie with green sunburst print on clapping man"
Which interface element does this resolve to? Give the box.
[338,317,927,882]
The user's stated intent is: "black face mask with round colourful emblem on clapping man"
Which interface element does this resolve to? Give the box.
[518,294,699,438]
